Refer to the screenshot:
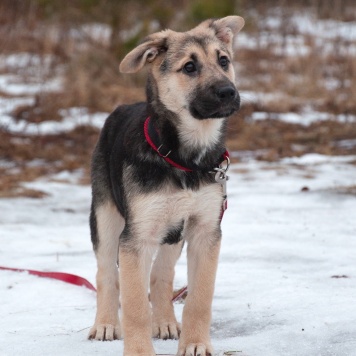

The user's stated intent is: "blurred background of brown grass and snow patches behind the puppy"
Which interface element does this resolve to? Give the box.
[0,0,356,198]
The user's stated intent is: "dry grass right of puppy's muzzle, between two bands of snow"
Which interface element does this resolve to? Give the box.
[238,34,356,115]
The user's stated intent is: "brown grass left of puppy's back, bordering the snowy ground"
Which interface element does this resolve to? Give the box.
[0,126,99,198]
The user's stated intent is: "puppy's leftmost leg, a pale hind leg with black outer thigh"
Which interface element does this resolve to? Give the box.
[88,200,125,340]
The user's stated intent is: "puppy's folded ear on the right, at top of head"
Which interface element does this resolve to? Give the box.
[210,16,245,46]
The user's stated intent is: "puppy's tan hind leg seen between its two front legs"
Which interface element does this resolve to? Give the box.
[150,241,183,339]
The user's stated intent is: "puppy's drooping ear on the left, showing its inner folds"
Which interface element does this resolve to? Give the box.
[119,31,168,73]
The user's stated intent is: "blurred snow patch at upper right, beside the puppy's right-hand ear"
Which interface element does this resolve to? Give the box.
[236,8,356,57]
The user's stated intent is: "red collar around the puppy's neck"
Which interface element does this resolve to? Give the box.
[144,117,229,172]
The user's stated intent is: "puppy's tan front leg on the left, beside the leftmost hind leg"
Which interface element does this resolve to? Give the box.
[119,244,155,356]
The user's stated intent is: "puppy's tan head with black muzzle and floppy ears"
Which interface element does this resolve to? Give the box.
[120,16,244,120]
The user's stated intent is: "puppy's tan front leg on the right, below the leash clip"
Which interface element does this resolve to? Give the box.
[178,229,221,356]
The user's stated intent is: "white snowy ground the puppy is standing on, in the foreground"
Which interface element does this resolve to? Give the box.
[0,155,356,356]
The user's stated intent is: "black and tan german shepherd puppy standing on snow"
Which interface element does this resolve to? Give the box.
[89,16,244,356]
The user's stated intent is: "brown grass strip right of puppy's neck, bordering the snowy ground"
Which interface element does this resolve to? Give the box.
[228,113,356,161]
